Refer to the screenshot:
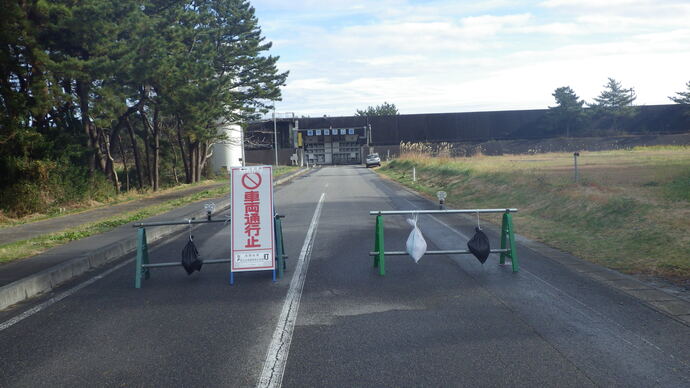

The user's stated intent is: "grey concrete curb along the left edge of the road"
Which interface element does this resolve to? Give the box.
[0,168,310,311]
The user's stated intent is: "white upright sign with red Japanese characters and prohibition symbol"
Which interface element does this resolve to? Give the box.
[230,166,275,272]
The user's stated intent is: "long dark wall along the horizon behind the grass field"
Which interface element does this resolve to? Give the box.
[288,104,690,145]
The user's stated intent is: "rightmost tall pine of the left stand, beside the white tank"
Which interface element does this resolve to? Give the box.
[155,0,288,181]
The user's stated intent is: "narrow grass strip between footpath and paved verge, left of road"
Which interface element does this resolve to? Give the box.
[0,166,297,263]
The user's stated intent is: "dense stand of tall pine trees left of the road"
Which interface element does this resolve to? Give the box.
[0,0,287,216]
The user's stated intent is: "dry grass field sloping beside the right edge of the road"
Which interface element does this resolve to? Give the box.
[379,146,690,287]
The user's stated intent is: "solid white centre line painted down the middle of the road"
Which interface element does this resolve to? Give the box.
[257,193,326,388]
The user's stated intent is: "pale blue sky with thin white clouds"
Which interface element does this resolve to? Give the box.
[251,0,690,116]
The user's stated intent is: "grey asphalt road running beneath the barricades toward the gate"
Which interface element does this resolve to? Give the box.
[0,167,690,387]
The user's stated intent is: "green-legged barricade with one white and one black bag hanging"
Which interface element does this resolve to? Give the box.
[369,208,520,276]
